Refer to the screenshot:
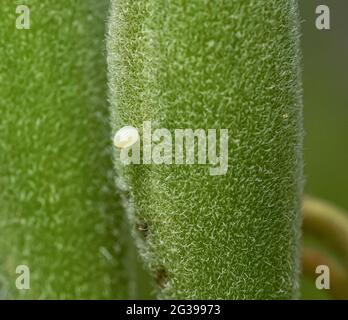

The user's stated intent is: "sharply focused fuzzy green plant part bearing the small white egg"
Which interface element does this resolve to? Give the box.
[108,0,303,299]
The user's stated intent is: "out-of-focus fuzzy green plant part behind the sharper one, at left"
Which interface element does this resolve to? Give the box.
[0,0,134,299]
